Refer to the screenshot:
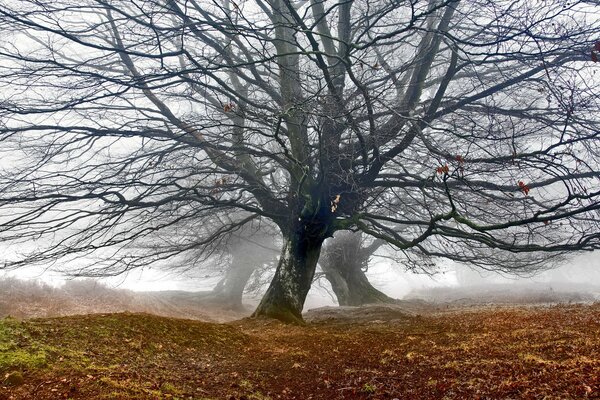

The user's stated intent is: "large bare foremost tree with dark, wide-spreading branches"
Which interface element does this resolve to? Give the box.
[0,0,600,322]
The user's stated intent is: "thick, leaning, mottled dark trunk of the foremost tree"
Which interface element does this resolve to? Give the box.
[252,229,324,324]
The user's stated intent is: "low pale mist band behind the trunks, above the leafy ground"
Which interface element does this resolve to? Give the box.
[0,249,600,321]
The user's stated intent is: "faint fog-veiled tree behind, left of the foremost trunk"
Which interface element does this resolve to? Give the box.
[126,211,281,310]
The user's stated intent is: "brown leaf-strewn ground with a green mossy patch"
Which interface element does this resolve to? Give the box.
[0,303,600,400]
